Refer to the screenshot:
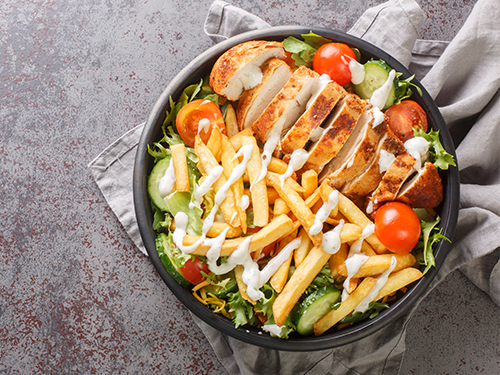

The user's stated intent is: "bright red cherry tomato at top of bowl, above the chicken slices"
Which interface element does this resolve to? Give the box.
[313,43,356,86]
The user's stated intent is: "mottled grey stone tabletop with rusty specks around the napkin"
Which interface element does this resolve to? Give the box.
[0,0,500,374]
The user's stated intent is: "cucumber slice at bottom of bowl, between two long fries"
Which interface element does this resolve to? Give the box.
[294,286,340,336]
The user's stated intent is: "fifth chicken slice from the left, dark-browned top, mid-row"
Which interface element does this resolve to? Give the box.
[305,95,366,170]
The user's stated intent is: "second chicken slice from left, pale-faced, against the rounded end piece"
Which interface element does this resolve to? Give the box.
[236,58,292,130]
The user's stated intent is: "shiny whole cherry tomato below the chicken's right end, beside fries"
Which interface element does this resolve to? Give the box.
[375,202,421,254]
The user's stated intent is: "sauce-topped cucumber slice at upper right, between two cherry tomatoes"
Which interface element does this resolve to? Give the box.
[354,60,397,109]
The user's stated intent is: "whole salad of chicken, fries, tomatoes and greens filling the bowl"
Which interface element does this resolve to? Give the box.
[148,33,455,339]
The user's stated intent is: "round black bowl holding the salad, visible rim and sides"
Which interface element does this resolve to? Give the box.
[133,26,459,351]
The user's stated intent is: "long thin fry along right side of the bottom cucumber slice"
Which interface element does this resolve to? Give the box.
[314,277,377,336]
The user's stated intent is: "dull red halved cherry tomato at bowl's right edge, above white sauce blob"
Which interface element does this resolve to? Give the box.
[385,100,427,142]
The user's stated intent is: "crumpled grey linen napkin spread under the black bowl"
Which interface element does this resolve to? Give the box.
[89,0,500,374]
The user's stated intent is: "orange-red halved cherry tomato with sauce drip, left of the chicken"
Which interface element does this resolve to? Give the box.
[175,99,226,147]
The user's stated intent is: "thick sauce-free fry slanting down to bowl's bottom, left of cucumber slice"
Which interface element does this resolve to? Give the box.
[273,246,331,326]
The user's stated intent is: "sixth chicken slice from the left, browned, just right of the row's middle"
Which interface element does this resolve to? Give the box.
[319,112,380,189]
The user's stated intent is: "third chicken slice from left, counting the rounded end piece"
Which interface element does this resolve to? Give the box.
[252,66,319,142]
